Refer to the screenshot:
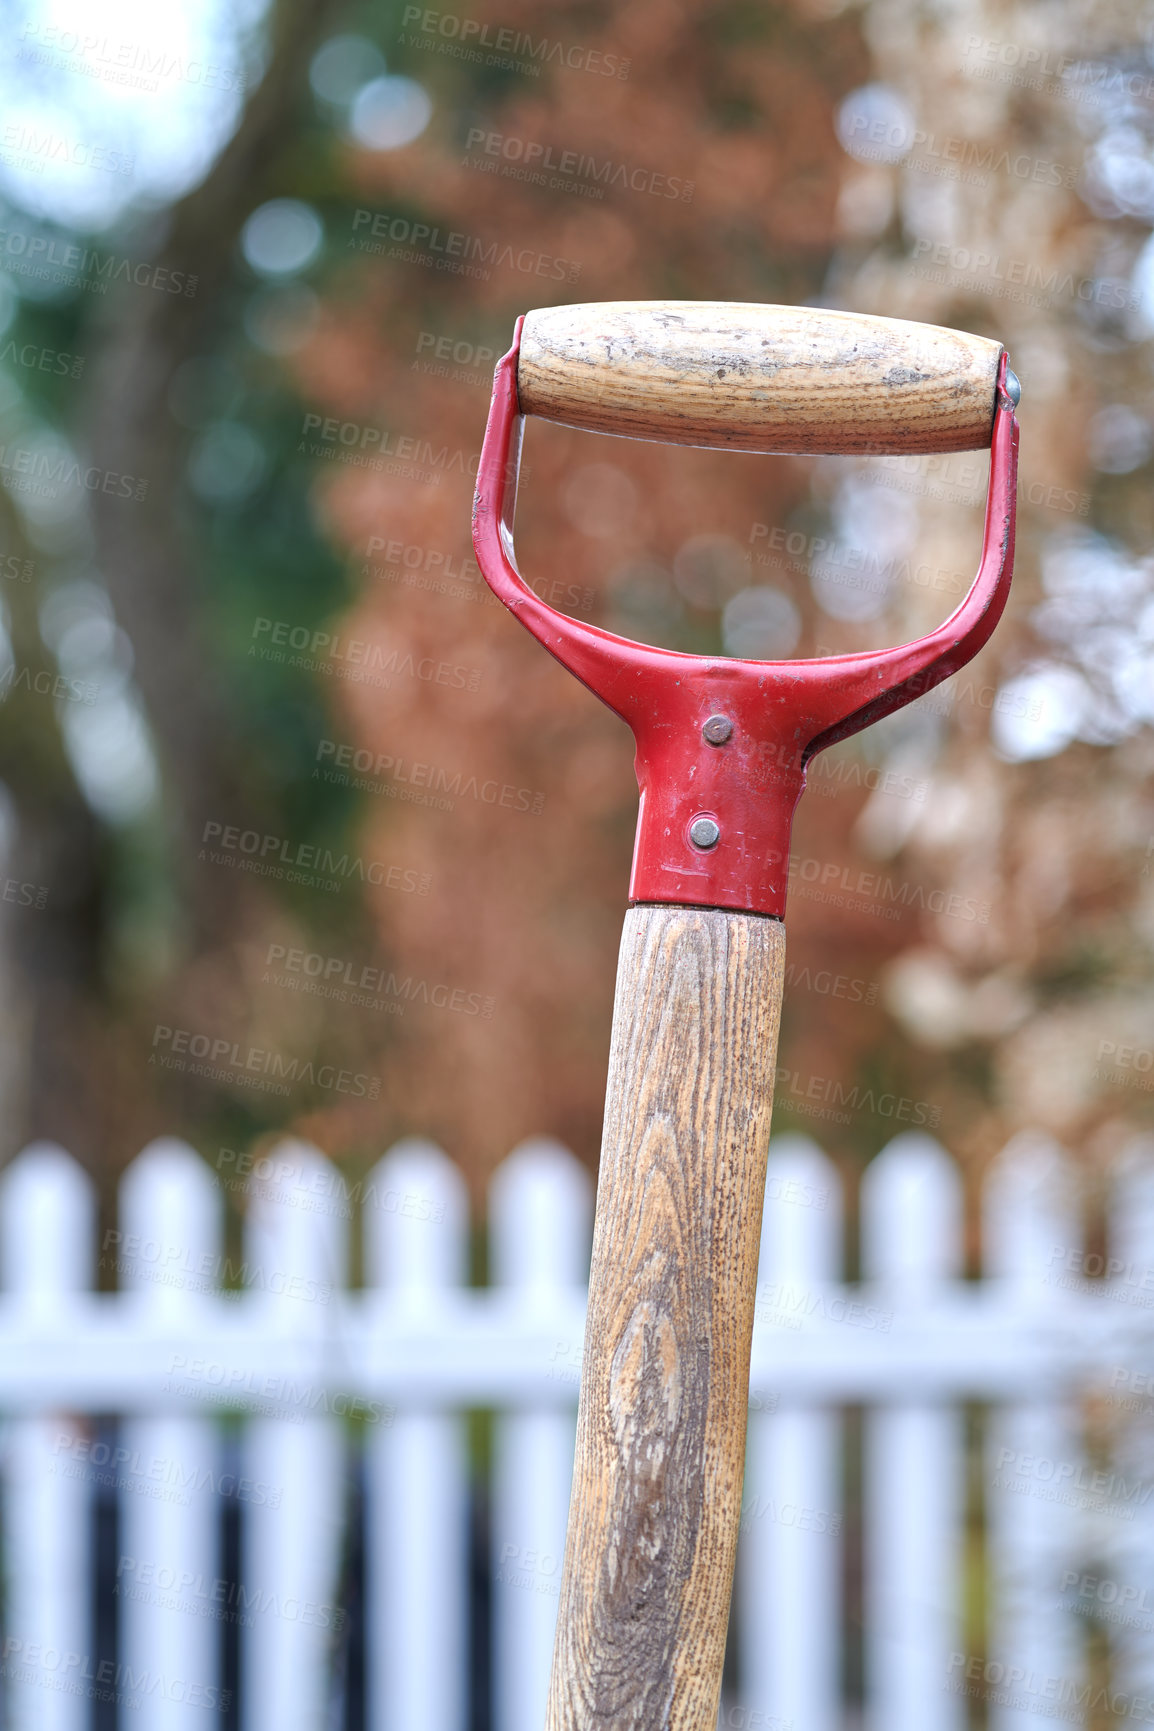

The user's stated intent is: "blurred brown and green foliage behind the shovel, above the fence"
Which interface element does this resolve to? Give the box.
[0,0,1154,1211]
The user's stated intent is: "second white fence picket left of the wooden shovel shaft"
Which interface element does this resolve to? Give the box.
[365,1139,469,1731]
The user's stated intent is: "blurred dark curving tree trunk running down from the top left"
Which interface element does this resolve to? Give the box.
[83,0,341,950]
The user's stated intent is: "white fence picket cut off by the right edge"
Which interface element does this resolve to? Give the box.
[1100,1136,1154,1702]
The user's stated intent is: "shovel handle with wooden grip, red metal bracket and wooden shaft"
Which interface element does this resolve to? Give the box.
[472,301,1021,1731]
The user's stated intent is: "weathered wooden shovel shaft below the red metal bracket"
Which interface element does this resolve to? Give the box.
[547,905,785,1731]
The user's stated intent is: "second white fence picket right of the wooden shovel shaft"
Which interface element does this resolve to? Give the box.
[862,1132,965,1731]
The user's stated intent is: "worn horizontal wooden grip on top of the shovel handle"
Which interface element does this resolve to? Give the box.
[517,301,1002,455]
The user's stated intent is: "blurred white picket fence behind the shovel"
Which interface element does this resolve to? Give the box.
[0,1134,1154,1731]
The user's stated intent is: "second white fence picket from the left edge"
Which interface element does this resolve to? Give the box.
[116,1137,224,1731]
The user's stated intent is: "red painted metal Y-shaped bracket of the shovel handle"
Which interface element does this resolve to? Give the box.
[472,320,1017,919]
